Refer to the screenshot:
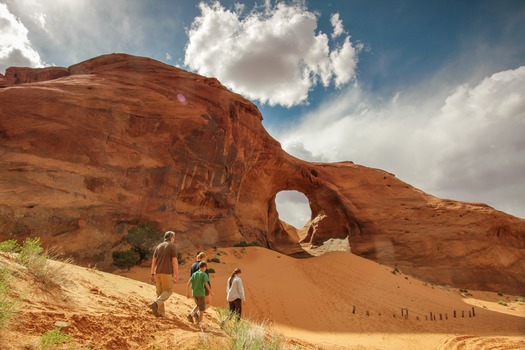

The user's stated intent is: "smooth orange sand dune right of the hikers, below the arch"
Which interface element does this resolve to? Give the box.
[152,248,525,348]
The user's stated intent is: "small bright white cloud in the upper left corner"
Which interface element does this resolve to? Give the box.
[0,4,43,72]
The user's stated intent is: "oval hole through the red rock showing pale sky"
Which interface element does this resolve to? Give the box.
[275,191,312,229]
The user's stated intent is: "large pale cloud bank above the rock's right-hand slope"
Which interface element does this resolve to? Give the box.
[275,66,525,217]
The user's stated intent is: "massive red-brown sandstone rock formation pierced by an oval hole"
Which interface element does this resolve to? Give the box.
[0,54,525,292]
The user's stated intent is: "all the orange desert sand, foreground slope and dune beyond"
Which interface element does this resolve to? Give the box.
[0,247,525,349]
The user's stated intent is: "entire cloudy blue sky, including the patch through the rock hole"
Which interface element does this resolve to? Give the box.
[0,0,525,225]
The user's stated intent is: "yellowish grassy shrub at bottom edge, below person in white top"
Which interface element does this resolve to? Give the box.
[216,308,284,350]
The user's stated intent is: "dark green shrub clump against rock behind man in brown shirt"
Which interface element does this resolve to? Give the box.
[122,224,163,264]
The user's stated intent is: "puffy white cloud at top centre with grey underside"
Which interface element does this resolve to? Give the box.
[184,2,358,107]
